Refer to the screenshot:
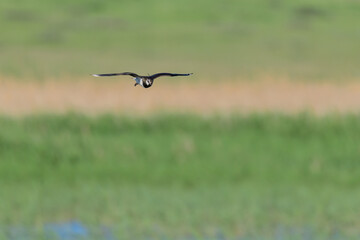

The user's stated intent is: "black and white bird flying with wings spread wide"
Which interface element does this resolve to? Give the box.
[92,72,192,88]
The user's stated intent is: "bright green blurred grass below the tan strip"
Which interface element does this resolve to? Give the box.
[0,114,360,239]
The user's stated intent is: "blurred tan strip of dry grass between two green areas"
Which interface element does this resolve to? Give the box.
[0,78,360,115]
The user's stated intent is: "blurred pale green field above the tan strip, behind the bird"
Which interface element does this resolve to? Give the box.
[0,0,360,80]
